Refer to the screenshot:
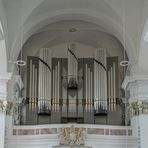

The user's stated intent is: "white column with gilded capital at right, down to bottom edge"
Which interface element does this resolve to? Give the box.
[122,74,148,148]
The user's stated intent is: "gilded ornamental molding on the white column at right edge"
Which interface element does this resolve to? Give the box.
[128,100,148,116]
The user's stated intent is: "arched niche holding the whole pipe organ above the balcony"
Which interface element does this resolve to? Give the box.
[13,20,130,125]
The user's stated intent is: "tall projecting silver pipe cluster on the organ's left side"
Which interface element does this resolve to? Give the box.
[34,48,51,112]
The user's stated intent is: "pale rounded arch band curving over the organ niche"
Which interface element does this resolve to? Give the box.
[11,8,137,63]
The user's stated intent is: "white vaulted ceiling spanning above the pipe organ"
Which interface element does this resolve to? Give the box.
[0,0,148,72]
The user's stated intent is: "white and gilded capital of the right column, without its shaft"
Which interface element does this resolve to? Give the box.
[122,75,148,116]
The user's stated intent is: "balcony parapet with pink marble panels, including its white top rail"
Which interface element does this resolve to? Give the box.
[12,124,133,136]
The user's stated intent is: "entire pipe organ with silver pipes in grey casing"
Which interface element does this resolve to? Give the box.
[26,47,119,123]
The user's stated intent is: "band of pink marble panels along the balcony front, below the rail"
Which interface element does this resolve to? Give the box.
[12,126,133,137]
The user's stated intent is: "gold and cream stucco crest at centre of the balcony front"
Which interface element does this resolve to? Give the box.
[59,125,85,146]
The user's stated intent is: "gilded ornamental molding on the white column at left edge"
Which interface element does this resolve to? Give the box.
[0,100,16,115]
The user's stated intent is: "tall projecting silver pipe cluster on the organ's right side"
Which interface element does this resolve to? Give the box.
[94,49,107,113]
